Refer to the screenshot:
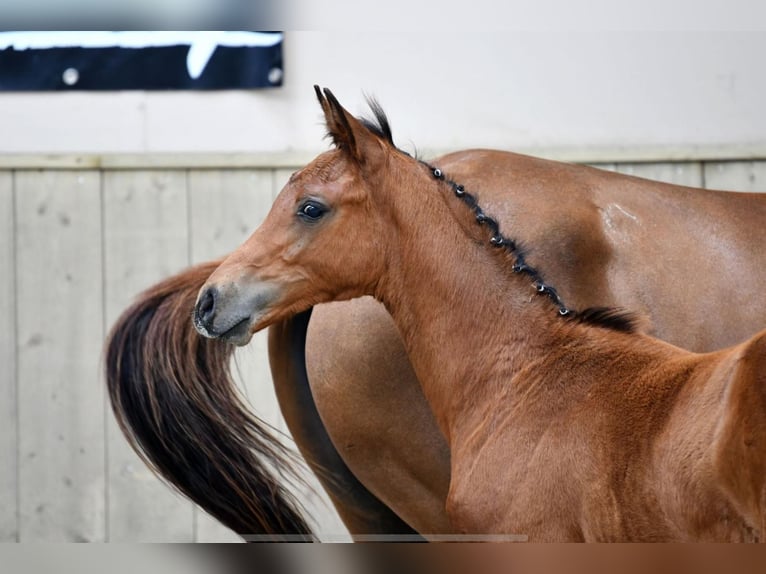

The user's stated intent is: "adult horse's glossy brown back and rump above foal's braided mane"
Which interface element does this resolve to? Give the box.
[435,150,766,352]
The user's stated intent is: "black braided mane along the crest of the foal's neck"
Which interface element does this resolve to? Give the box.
[424,162,637,333]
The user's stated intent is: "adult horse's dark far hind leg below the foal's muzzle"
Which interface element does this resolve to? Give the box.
[269,310,426,539]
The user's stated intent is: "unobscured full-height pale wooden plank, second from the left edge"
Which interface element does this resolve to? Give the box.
[15,171,105,542]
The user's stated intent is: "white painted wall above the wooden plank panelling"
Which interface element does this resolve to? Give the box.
[0,27,766,153]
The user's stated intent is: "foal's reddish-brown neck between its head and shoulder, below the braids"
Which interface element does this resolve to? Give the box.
[376,164,565,440]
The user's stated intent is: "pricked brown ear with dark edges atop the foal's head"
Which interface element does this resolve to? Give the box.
[314,86,384,165]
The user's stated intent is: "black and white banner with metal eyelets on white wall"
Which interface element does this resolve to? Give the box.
[0,31,284,91]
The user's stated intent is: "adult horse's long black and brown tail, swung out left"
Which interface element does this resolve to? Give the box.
[105,261,314,541]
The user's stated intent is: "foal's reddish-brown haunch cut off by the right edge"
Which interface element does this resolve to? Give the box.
[714,331,766,538]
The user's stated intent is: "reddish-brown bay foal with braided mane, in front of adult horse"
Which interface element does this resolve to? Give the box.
[196,91,766,540]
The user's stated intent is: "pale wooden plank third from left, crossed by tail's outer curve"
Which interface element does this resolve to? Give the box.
[104,171,193,542]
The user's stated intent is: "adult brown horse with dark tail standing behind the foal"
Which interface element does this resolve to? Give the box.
[107,88,766,544]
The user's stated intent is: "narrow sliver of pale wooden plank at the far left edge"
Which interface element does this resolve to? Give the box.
[0,172,19,542]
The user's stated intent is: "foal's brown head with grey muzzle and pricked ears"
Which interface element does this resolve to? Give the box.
[194,86,415,344]
